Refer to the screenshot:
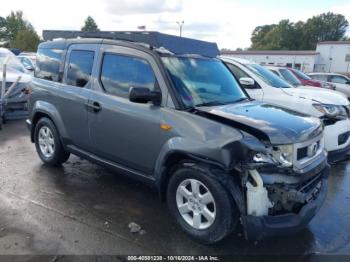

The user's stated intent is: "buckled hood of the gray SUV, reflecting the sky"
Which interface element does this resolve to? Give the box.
[198,101,322,145]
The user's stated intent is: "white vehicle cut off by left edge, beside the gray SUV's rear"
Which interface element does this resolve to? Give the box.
[0,48,32,125]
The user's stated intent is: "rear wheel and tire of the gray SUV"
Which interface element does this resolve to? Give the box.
[34,117,70,166]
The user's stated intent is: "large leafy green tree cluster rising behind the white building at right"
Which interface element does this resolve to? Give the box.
[250,12,349,50]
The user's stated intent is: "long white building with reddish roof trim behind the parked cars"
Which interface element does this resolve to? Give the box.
[221,41,350,73]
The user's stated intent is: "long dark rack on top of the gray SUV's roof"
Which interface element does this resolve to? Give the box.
[43,30,220,57]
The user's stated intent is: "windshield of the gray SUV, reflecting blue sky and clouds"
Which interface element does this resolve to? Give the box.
[162,56,247,107]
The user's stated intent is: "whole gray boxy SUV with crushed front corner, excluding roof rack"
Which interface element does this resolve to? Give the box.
[27,36,329,244]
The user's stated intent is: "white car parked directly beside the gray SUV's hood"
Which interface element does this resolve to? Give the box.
[222,57,350,162]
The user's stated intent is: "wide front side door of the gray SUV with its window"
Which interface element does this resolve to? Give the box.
[89,45,166,174]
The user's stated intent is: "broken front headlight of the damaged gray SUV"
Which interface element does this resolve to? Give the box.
[253,145,294,167]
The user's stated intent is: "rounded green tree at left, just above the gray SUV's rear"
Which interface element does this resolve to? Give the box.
[10,28,40,52]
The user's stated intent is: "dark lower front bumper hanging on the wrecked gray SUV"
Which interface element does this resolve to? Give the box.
[246,165,330,239]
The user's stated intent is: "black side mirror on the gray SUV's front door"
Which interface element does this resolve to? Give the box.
[129,87,162,106]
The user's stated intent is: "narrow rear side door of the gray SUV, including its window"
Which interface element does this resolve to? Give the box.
[59,44,99,150]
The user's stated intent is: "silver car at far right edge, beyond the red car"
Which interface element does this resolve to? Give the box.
[308,73,350,98]
